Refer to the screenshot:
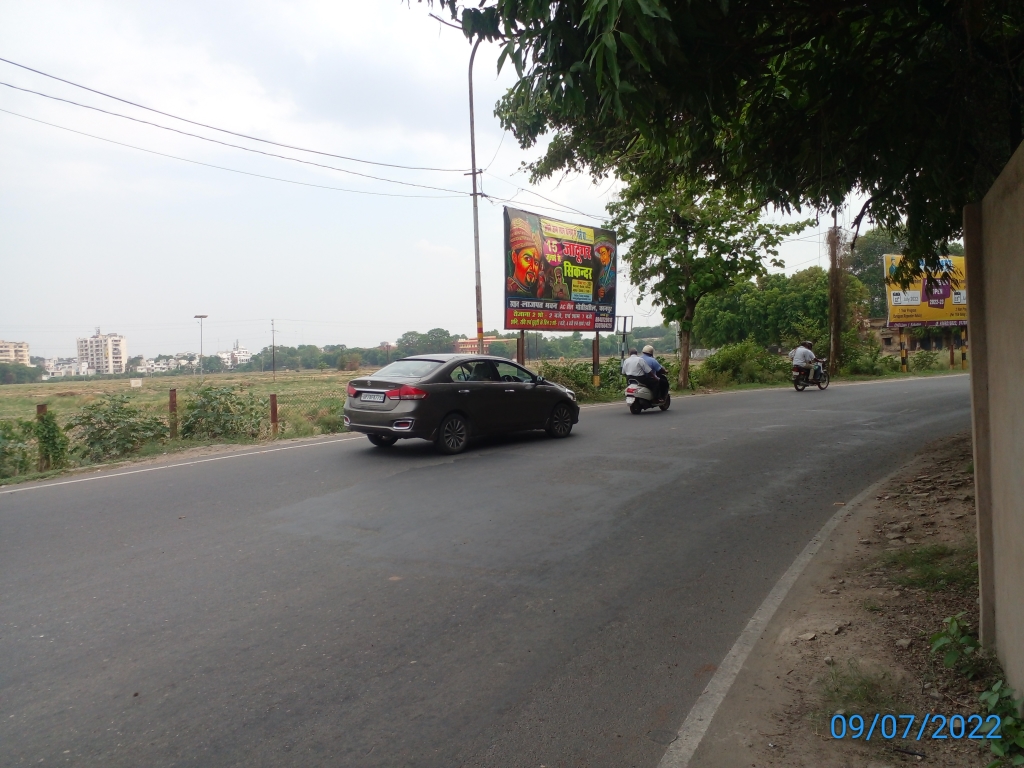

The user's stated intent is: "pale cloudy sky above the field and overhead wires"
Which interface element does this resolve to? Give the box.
[0,0,821,356]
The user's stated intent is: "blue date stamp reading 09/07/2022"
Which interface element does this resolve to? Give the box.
[829,713,1002,741]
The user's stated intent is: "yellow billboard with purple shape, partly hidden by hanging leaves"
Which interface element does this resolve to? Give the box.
[883,254,967,328]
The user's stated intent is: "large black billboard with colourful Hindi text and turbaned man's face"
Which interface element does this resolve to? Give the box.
[505,208,618,331]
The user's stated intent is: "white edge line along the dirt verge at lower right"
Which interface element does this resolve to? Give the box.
[657,470,900,768]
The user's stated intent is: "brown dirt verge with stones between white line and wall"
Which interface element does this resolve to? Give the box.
[690,433,992,768]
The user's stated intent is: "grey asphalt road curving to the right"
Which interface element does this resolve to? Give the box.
[0,377,970,768]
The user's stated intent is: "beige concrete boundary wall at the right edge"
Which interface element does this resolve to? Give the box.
[964,144,1024,691]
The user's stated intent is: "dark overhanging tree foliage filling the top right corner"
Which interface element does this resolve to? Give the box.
[438,0,1024,278]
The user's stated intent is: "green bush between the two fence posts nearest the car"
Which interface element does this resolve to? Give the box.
[181,385,270,439]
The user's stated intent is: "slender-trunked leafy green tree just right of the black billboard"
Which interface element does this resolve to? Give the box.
[608,177,810,387]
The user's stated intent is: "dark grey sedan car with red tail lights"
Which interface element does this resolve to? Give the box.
[345,354,580,454]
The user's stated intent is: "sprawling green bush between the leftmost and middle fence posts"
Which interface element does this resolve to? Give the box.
[65,394,168,462]
